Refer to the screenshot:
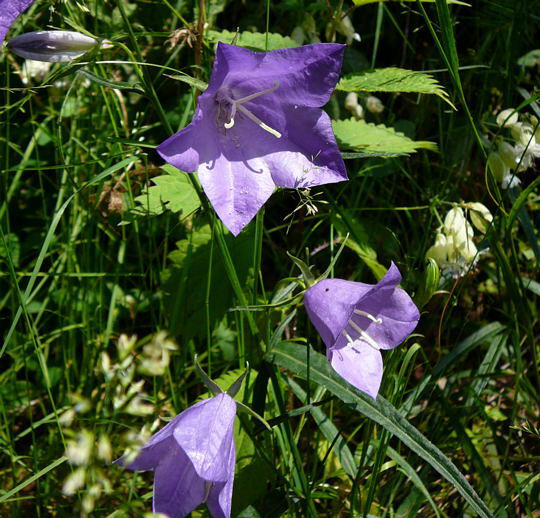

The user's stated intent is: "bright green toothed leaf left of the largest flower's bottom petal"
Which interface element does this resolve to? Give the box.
[133,164,201,216]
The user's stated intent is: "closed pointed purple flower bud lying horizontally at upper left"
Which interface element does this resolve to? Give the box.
[7,31,106,63]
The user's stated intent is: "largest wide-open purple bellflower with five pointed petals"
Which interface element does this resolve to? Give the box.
[157,43,347,235]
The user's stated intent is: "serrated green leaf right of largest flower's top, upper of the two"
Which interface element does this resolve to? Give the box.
[336,67,451,104]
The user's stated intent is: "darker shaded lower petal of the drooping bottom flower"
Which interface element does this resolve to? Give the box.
[153,445,206,518]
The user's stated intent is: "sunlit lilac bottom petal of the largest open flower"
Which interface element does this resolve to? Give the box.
[198,147,275,236]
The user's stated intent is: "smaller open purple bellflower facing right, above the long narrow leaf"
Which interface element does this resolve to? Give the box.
[304,263,420,399]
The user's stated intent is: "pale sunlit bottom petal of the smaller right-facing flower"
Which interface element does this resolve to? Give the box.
[328,342,383,399]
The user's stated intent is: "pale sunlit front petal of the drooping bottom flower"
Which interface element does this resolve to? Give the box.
[173,394,236,482]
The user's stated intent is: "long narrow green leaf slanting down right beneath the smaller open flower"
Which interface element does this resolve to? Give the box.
[267,342,493,518]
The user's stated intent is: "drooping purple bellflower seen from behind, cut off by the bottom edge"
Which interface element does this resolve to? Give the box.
[116,393,236,518]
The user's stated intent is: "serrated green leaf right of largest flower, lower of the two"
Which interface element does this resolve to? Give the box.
[332,119,437,156]
